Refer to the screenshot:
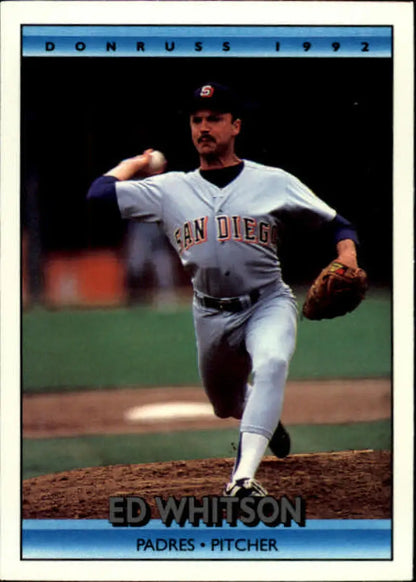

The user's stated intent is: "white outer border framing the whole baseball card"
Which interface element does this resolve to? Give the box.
[0,0,414,581]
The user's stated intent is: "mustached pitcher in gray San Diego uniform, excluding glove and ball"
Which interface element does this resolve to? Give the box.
[88,83,357,498]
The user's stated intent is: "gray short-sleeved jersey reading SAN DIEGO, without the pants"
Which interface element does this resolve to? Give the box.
[116,161,336,297]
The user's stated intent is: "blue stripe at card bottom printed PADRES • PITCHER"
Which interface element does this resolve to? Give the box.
[22,520,392,560]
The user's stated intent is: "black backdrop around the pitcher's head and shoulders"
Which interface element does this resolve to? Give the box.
[21,56,392,284]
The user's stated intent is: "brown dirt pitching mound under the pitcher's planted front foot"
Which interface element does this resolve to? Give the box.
[23,450,391,519]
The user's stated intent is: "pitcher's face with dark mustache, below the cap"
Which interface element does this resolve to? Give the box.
[190,109,241,156]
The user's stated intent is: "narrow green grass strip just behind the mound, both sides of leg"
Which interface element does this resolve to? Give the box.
[22,420,391,479]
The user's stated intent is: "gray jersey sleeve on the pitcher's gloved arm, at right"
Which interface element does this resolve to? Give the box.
[285,174,336,228]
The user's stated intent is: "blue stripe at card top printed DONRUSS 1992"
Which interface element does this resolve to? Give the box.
[22,26,392,58]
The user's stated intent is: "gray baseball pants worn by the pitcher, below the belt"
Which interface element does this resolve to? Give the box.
[193,283,297,439]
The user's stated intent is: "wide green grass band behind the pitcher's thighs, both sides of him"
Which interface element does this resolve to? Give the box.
[22,292,391,392]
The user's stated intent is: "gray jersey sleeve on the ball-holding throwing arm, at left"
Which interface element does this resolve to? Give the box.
[115,176,163,222]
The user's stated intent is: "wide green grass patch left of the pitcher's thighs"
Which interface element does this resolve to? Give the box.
[23,307,198,391]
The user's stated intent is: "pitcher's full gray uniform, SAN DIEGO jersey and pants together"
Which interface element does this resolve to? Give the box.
[115,161,336,439]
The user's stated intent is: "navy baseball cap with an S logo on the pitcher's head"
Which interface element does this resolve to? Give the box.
[188,83,241,116]
